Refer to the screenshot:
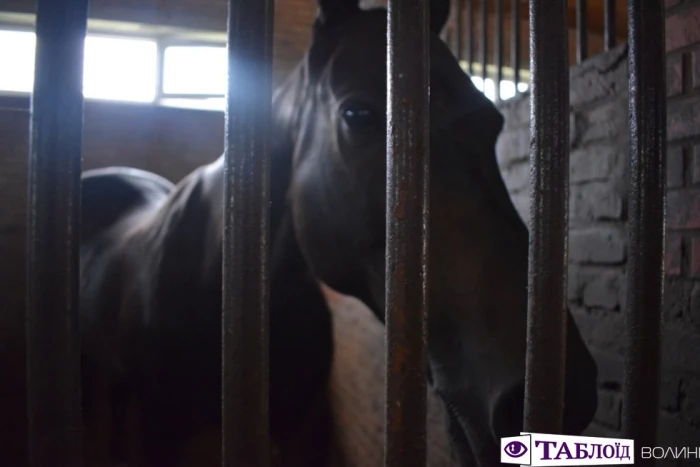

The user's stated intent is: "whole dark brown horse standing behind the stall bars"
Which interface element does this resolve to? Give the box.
[81,0,597,466]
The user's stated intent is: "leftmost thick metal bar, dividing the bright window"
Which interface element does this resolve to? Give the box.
[26,0,89,467]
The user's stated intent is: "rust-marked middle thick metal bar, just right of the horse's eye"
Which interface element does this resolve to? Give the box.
[384,0,430,467]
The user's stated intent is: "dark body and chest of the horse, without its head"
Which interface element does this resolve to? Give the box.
[80,165,333,467]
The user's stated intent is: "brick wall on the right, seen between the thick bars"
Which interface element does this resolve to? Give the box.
[498,0,700,465]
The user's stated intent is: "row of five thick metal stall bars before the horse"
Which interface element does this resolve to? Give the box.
[27,0,666,467]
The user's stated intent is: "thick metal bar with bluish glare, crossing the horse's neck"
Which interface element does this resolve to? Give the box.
[222,0,274,467]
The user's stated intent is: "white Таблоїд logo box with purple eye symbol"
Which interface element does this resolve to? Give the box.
[501,432,634,466]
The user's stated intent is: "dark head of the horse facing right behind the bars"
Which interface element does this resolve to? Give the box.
[274,0,597,465]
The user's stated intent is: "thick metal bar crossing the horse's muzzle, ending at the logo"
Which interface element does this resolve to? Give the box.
[525,0,569,434]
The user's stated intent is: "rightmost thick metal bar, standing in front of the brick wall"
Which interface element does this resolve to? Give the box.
[622,0,666,466]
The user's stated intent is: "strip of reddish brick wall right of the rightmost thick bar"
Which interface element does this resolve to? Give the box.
[661,0,700,458]
